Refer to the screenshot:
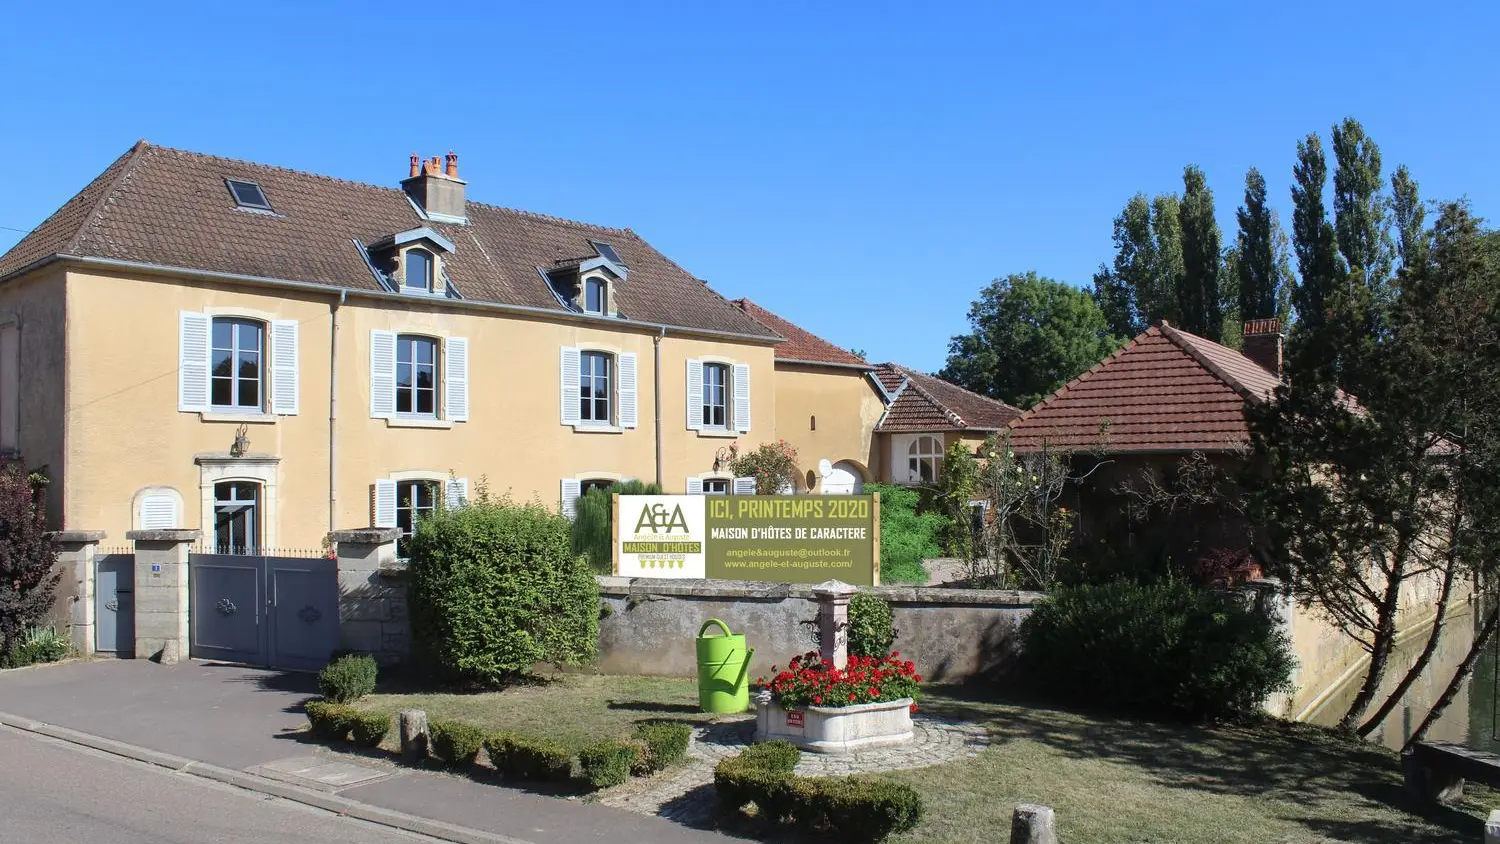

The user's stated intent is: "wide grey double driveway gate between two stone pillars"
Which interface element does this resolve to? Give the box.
[188,553,339,669]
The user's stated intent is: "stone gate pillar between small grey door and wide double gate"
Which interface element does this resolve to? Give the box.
[125,529,203,666]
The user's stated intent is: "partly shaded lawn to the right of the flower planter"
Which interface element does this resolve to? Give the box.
[890,688,1494,844]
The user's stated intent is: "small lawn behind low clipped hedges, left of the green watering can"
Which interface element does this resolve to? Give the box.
[357,675,719,751]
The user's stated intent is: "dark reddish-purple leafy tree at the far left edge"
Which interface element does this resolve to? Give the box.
[0,463,62,655]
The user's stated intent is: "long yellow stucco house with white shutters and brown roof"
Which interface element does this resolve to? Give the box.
[0,141,912,550]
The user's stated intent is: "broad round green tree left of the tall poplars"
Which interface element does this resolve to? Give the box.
[941,271,1118,408]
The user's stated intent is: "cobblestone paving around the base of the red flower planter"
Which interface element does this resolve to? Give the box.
[599,715,990,826]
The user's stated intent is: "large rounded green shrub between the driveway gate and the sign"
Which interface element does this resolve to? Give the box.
[410,499,599,687]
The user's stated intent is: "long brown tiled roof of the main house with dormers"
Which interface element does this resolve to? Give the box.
[0,141,776,340]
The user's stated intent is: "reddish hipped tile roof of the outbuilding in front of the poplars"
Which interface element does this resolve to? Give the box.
[1011,324,1277,453]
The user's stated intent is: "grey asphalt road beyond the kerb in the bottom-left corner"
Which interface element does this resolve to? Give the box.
[0,727,434,844]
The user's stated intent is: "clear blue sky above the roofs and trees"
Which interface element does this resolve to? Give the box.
[0,1,1500,369]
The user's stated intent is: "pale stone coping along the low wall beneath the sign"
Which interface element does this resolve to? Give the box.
[597,574,1047,607]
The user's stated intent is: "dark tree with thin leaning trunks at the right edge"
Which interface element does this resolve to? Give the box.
[1247,200,1500,735]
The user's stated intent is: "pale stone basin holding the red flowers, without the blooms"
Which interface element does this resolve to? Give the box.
[755,693,912,753]
